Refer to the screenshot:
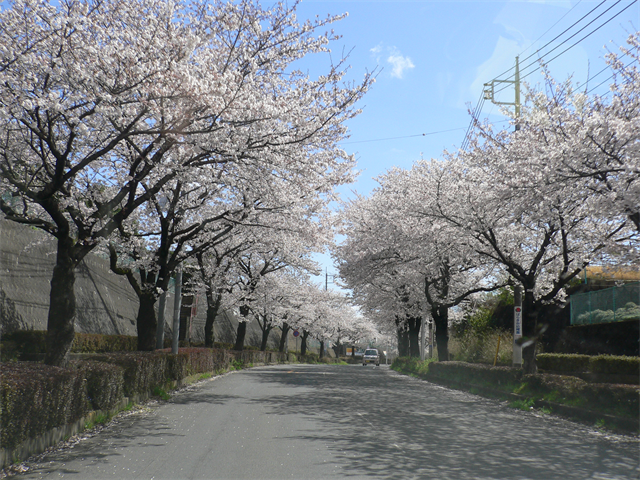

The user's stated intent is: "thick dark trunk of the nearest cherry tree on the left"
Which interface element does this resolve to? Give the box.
[44,238,78,367]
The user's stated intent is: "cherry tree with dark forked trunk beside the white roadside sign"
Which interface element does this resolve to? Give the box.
[430,125,630,372]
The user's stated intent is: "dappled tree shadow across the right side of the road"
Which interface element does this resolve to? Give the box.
[247,366,640,480]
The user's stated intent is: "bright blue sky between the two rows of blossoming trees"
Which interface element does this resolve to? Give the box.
[298,0,640,284]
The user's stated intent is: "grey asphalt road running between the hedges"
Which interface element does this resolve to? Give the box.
[8,365,640,480]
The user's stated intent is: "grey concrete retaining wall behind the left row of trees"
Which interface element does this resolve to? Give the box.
[0,217,295,349]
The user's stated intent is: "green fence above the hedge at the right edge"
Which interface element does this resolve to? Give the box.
[571,282,640,325]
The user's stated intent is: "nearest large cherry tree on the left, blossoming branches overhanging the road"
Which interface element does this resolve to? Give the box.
[0,0,372,365]
